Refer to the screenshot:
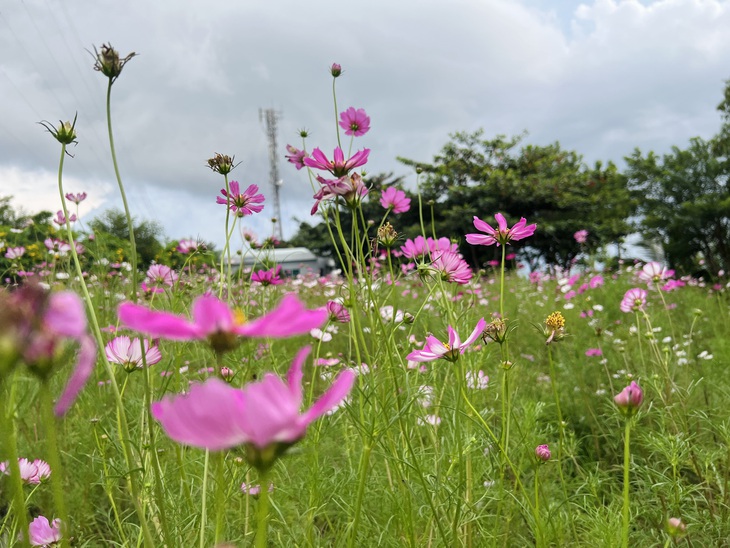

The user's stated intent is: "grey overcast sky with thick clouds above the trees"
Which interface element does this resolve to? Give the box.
[0,0,730,248]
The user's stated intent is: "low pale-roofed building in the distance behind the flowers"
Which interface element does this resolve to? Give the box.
[231,247,336,276]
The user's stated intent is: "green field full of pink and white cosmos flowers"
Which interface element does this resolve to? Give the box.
[0,46,730,548]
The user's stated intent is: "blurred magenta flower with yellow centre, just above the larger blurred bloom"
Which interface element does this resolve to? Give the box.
[118,294,327,352]
